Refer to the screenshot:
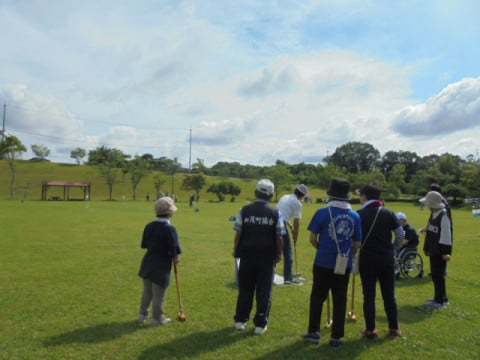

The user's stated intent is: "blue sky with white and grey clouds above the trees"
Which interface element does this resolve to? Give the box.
[0,0,480,166]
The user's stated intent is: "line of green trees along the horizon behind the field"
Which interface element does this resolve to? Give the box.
[0,135,480,203]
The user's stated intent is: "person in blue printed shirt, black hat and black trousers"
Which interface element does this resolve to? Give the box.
[302,178,362,347]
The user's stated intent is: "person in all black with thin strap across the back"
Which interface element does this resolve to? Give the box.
[358,184,405,339]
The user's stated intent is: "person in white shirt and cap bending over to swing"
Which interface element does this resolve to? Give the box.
[277,184,307,285]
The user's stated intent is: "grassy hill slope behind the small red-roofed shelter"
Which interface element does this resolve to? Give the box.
[0,160,325,202]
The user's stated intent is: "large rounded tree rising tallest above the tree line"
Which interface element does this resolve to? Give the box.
[326,141,380,173]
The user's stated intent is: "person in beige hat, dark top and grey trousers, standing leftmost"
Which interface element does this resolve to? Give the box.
[138,196,182,326]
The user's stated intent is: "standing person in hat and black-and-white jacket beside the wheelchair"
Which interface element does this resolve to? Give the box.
[420,191,453,309]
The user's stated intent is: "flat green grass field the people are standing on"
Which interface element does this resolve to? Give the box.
[0,200,480,359]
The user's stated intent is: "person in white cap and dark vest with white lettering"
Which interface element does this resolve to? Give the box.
[233,179,285,334]
